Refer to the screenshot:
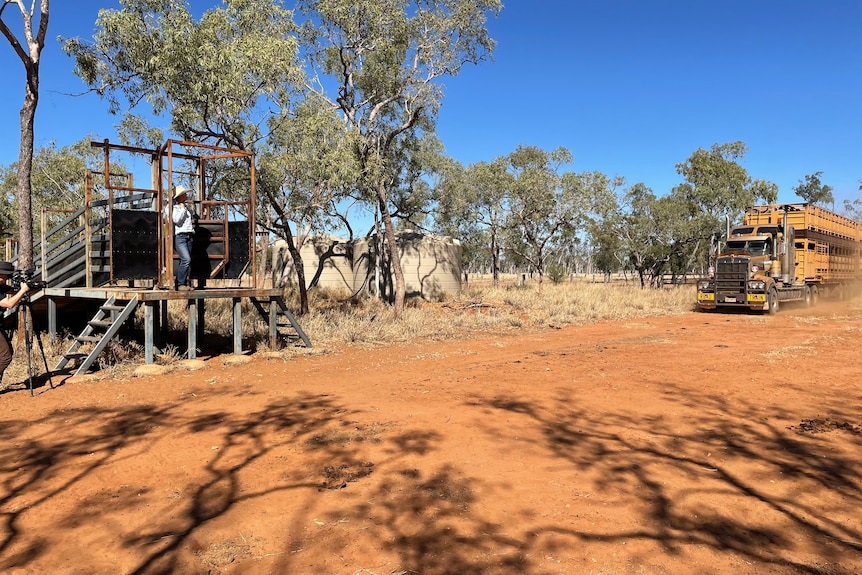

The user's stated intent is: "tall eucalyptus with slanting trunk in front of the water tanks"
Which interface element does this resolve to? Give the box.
[298,0,502,313]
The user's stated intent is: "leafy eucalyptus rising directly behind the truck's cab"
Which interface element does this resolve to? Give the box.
[671,142,778,274]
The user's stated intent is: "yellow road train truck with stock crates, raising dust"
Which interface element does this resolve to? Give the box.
[697,204,862,314]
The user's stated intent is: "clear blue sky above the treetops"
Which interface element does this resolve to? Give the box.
[0,0,862,208]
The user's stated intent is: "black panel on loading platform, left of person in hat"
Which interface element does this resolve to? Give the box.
[112,210,159,279]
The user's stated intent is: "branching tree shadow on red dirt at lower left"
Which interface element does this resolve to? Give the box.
[0,395,343,573]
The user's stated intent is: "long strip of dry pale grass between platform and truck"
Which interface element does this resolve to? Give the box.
[294,283,694,345]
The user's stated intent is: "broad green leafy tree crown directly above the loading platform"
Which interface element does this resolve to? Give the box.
[61,0,304,150]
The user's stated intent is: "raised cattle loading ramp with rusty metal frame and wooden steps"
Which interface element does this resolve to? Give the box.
[7,140,311,375]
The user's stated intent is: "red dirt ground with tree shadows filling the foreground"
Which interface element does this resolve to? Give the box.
[0,304,862,575]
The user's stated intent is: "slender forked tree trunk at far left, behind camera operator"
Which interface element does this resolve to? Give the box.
[0,0,50,272]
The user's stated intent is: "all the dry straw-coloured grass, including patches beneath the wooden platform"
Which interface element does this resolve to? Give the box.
[3,281,862,385]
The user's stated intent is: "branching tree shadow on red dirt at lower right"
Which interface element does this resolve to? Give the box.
[462,384,862,575]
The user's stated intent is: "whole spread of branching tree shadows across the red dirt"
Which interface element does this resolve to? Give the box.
[0,376,862,575]
